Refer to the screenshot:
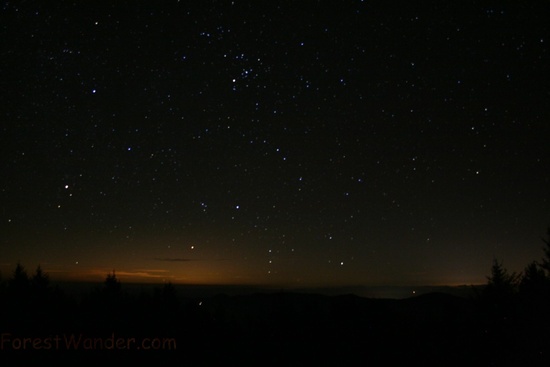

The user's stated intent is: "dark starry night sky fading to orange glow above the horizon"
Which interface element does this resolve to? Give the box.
[0,1,550,287]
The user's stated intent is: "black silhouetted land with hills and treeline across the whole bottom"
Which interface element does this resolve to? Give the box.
[0,230,550,366]
